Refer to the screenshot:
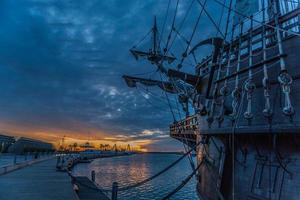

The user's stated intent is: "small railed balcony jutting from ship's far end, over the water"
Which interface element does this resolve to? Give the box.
[170,115,198,134]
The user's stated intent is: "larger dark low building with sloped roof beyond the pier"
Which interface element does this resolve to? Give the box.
[8,137,54,154]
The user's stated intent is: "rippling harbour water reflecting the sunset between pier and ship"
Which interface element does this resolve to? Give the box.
[73,154,198,200]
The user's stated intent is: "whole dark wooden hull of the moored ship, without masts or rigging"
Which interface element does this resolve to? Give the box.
[170,6,300,200]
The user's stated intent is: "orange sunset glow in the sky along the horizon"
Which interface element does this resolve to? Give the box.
[0,122,153,152]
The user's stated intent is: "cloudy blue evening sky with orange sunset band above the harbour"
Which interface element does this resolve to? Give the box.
[0,0,223,151]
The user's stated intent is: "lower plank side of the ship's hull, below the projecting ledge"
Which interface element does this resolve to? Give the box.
[197,134,300,200]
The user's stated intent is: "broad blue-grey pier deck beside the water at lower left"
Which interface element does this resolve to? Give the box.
[0,159,77,200]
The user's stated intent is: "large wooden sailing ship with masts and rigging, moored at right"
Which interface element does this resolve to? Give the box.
[123,0,300,200]
